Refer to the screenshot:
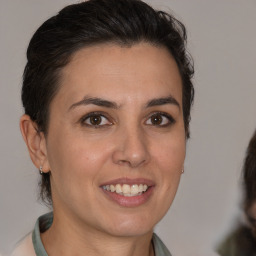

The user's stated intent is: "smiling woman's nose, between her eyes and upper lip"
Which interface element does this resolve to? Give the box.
[113,127,150,168]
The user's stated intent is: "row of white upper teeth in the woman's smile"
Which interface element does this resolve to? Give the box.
[103,184,148,196]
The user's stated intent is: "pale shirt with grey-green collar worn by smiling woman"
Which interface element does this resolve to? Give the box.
[11,212,171,256]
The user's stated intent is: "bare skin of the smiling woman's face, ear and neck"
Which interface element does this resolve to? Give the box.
[21,43,186,256]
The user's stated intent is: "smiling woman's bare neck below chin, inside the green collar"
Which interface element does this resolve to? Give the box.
[41,211,154,256]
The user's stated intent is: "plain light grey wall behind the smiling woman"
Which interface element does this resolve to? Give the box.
[0,0,256,256]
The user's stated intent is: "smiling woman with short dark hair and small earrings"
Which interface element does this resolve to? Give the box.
[11,0,194,256]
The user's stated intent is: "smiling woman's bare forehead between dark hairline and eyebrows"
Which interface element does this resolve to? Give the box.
[54,43,182,106]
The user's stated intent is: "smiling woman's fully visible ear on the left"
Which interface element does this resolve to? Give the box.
[20,115,50,173]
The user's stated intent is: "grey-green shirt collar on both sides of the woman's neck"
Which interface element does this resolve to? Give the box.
[32,212,171,256]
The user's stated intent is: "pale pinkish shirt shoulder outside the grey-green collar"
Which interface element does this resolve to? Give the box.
[11,233,36,256]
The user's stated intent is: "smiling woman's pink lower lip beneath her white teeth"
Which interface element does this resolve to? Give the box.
[102,186,154,207]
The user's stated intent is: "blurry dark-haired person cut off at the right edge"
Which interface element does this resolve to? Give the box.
[218,130,256,256]
